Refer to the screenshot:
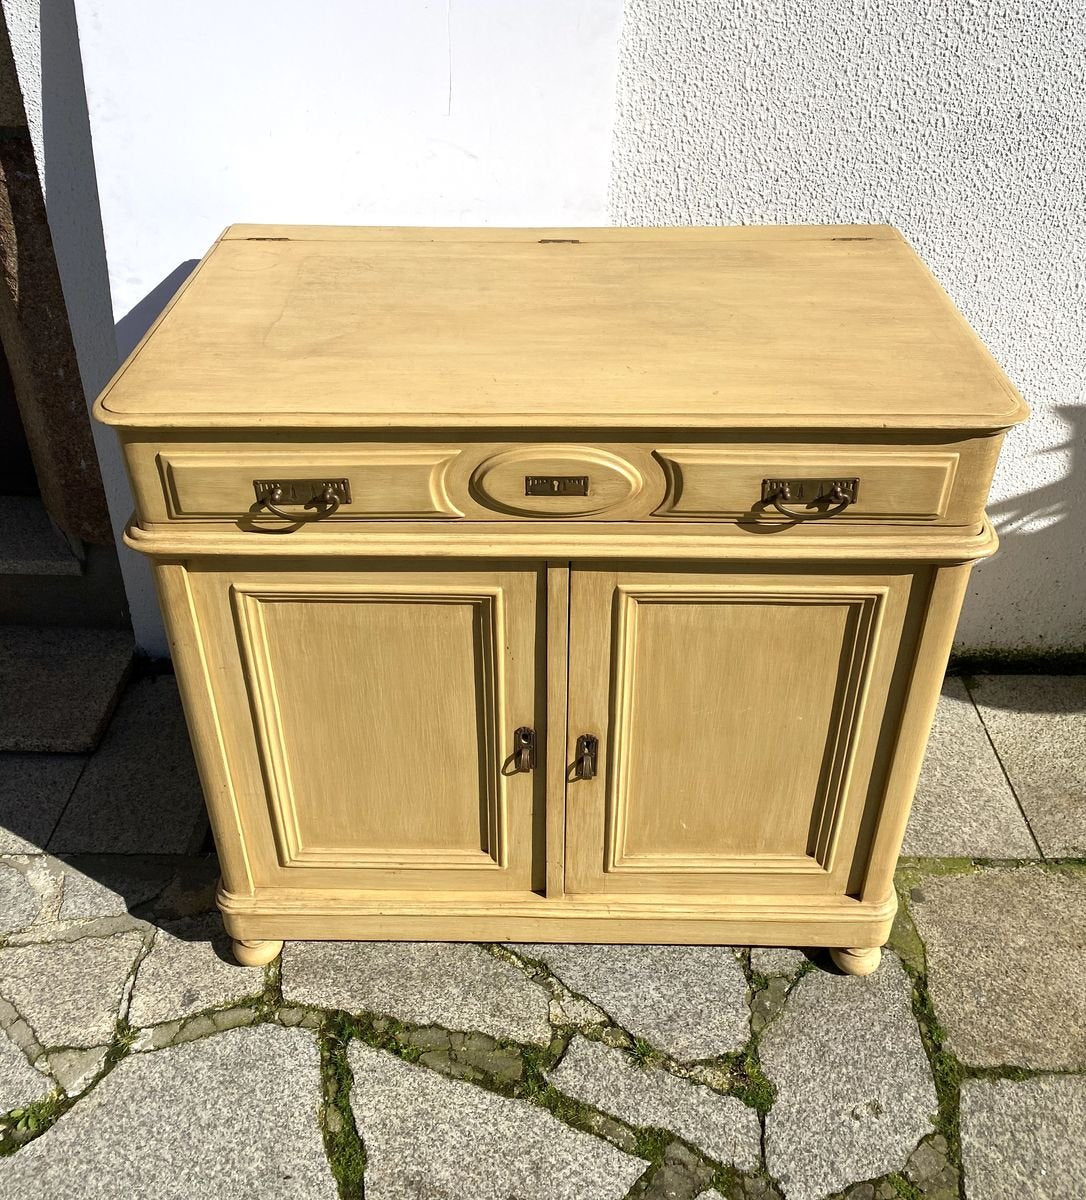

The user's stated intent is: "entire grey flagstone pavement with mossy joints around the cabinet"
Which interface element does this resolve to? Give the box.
[0,676,1086,1200]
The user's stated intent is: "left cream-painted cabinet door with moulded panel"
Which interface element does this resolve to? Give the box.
[187,559,545,893]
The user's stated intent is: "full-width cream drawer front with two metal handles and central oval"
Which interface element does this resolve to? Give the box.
[125,434,1000,528]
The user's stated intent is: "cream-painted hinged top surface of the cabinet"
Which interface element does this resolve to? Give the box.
[96,226,1026,430]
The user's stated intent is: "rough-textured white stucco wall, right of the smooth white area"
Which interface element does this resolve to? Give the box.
[611,0,1086,653]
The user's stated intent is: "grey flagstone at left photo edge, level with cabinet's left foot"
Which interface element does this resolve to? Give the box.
[0,932,143,1048]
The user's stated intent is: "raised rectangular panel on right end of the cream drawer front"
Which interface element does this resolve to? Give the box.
[655,445,960,522]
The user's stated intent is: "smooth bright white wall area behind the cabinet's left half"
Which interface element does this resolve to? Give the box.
[65,0,622,654]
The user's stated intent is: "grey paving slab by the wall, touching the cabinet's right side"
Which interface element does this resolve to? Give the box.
[901,679,1040,858]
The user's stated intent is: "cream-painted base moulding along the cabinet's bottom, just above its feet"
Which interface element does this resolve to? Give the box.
[218,888,898,948]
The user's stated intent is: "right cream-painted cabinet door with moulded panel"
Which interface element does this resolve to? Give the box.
[565,564,925,896]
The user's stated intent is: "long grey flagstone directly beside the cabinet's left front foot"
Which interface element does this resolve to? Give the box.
[282,942,551,1045]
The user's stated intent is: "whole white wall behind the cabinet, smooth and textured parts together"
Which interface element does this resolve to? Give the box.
[10,0,1086,653]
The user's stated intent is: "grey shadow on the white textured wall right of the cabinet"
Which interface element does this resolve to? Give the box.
[958,406,1086,673]
